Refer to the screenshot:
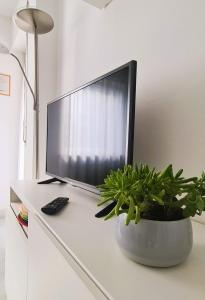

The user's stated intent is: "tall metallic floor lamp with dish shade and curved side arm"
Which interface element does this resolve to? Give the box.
[0,8,54,178]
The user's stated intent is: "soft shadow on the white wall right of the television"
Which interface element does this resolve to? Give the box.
[134,74,205,176]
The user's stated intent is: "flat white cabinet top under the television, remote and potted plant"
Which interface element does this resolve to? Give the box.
[12,181,205,300]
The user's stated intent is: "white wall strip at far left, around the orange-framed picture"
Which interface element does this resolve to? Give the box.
[0,54,22,210]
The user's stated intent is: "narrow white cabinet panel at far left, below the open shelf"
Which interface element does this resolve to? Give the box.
[5,209,28,300]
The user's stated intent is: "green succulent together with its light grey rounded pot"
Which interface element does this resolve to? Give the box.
[99,164,205,267]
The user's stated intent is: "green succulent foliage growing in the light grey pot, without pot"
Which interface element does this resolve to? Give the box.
[98,164,205,225]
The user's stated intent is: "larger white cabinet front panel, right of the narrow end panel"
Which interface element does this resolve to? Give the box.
[27,214,96,300]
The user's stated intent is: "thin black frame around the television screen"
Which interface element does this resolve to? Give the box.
[45,60,137,193]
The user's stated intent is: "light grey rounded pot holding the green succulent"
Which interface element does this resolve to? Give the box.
[116,214,193,267]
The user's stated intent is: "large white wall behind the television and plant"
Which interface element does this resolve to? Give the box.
[53,0,205,175]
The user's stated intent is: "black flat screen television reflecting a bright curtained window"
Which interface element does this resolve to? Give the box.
[46,61,137,188]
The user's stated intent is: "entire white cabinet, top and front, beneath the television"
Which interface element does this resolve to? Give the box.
[6,181,205,300]
